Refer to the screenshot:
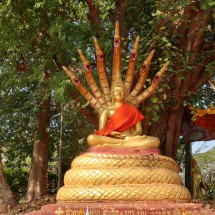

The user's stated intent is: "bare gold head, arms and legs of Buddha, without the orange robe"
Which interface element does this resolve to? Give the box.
[87,84,160,148]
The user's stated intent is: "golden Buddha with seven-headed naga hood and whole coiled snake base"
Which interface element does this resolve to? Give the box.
[57,22,191,202]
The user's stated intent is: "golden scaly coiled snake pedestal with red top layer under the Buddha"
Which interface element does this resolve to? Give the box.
[57,147,191,202]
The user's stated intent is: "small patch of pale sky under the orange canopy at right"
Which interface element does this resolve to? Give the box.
[192,140,215,154]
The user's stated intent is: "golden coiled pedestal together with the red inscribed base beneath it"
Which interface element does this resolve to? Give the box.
[25,147,214,215]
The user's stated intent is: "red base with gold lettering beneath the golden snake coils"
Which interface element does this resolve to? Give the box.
[25,201,215,215]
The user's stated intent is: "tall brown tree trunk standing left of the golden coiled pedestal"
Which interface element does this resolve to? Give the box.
[25,74,50,202]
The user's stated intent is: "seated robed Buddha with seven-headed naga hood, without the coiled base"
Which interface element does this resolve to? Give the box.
[63,22,168,148]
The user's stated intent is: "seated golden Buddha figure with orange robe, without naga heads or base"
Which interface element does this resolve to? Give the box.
[87,70,160,148]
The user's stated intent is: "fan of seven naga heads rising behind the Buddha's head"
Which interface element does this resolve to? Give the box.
[63,22,169,115]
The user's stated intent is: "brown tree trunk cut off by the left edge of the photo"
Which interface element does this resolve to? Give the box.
[0,155,17,214]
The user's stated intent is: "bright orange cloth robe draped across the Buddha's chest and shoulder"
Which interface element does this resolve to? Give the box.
[96,103,144,136]
